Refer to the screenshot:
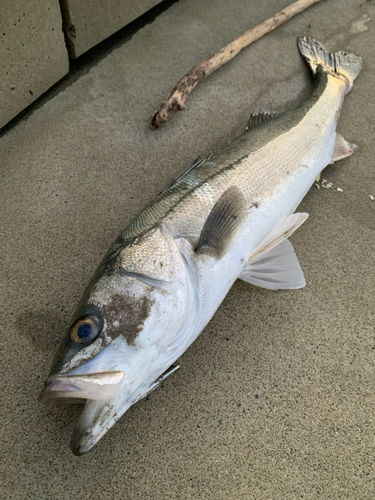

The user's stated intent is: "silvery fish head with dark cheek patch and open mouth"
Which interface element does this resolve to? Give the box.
[39,226,192,454]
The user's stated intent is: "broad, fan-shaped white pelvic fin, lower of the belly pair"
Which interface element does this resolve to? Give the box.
[240,240,306,290]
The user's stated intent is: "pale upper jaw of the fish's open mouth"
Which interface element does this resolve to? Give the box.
[38,370,124,406]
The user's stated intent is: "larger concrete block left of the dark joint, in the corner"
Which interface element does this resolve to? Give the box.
[0,0,69,128]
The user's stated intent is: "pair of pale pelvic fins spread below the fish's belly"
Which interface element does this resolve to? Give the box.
[240,213,308,290]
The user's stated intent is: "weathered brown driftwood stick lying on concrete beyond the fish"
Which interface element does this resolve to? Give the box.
[150,0,321,128]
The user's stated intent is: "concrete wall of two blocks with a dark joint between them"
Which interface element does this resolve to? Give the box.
[0,0,161,128]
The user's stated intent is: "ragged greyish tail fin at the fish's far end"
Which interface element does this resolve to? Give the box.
[298,36,362,92]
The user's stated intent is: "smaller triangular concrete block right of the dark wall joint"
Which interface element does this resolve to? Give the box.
[61,0,161,57]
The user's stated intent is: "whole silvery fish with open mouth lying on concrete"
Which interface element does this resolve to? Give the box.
[38,36,361,455]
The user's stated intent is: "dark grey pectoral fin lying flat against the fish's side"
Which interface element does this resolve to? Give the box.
[197,186,246,259]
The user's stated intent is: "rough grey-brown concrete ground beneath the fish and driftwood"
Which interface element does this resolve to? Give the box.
[0,0,375,500]
